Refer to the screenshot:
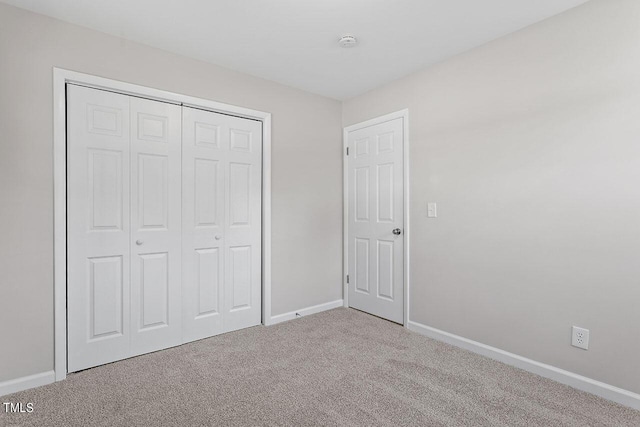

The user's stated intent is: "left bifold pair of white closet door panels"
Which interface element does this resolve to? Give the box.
[67,85,182,372]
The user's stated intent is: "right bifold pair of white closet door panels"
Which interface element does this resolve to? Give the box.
[182,107,262,341]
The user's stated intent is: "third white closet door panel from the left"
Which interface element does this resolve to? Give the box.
[182,107,228,341]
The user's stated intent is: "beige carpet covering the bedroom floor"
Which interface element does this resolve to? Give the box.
[0,308,640,427]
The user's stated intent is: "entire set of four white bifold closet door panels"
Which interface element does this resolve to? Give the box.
[67,85,262,372]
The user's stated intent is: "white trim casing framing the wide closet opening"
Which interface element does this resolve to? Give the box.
[53,67,271,381]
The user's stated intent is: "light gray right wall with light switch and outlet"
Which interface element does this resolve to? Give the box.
[343,0,640,392]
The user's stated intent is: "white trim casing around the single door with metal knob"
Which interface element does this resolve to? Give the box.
[342,108,411,327]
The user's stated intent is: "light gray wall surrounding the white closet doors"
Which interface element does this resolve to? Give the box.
[0,4,342,381]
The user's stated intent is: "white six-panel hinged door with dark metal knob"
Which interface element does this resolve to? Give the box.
[347,118,404,323]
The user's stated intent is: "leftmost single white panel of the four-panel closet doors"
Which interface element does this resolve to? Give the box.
[67,86,131,372]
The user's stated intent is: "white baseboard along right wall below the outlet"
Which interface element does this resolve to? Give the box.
[407,320,640,410]
